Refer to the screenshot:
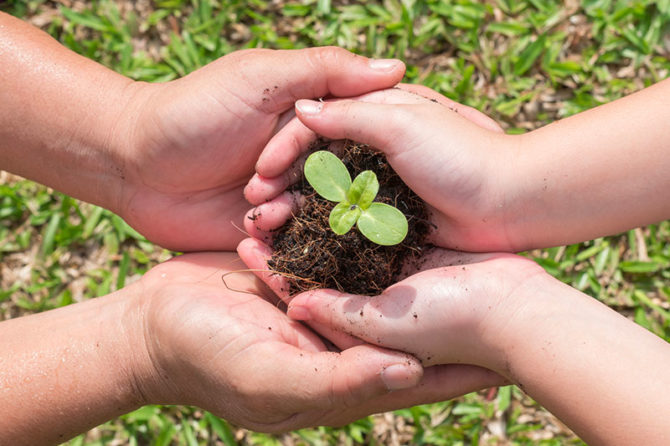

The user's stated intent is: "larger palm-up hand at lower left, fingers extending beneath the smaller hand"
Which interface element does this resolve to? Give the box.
[137,253,500,432]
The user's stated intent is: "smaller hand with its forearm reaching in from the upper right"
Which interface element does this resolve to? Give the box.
[247,80,670,251]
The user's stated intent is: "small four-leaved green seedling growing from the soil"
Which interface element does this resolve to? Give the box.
[305,150,407,246]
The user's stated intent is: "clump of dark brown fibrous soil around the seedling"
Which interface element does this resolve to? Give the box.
[268,141,430,296]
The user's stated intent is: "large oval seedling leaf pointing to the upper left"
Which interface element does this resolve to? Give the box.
[305,150,351,201]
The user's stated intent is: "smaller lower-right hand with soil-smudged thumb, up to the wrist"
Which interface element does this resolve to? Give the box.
[288,248,547,372]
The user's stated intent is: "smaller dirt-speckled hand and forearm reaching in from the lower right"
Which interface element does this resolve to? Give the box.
[288,251,670,445]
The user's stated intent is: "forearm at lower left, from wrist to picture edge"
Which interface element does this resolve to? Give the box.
[0,288,148,445]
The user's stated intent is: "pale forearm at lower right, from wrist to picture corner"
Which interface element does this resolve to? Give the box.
[498,278,670,445]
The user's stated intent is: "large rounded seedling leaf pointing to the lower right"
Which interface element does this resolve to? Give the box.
[358,203,407,246]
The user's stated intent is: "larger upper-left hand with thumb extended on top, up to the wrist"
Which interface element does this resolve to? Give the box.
[115,48,404,251]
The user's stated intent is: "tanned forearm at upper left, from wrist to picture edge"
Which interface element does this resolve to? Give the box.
[0,13,140,210]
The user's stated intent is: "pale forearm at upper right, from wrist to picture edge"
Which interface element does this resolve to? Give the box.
[505,80,670,250]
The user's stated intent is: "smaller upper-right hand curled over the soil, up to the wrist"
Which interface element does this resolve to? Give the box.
[246,86,515,251]
